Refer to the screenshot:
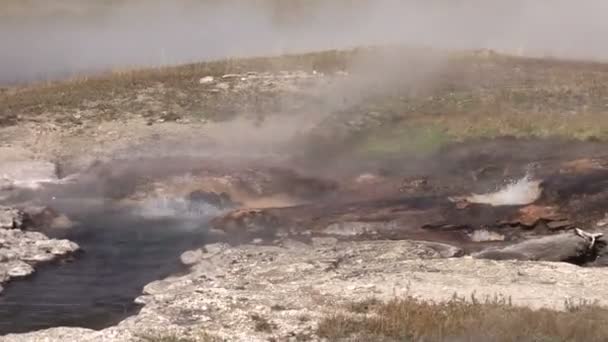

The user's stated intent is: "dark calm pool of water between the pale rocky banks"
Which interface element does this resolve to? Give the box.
[0,203,214,335]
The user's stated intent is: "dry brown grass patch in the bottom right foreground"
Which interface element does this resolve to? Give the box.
[318,297,608,342]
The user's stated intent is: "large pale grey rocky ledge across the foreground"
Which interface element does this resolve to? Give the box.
[5,238,608,342]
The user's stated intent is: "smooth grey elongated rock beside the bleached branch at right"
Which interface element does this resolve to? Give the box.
[473,232,592,263]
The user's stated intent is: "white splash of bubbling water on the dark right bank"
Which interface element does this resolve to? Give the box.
[467,175,542,206]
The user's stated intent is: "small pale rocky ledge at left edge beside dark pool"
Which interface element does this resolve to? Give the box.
[0,206,79,291]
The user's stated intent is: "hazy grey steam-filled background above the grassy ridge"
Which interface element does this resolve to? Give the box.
[0,0,608,84]
